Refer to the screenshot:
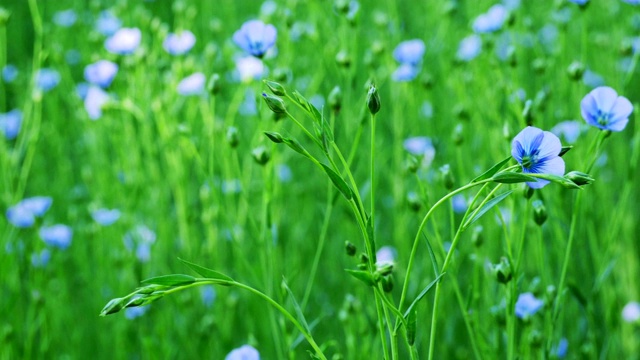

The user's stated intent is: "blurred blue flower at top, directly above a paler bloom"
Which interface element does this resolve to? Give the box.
[233,20,278,58]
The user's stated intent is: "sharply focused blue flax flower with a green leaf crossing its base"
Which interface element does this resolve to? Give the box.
[511,126,564,189]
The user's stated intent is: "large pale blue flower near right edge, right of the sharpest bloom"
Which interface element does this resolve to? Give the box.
[580,86,633,131]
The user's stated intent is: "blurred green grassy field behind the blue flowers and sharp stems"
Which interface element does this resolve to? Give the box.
[0,0,640,359]
